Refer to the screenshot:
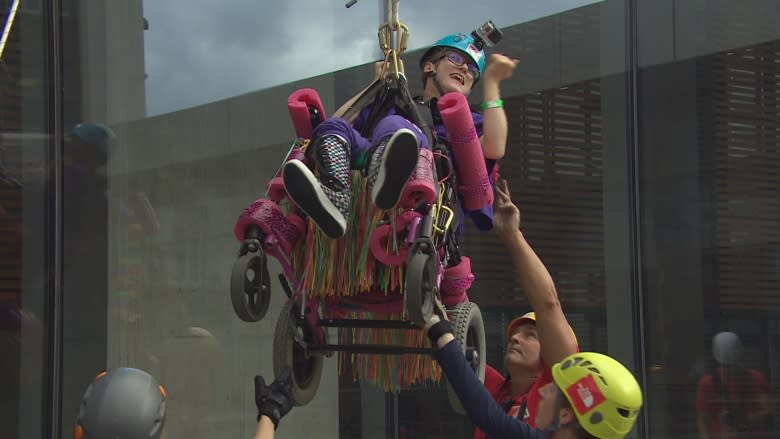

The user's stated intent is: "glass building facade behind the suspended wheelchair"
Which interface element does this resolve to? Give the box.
[0,0,780,439]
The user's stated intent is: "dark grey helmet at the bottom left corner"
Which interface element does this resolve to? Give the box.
[74,367,166,439]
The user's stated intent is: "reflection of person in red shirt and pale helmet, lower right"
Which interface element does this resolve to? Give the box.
[696,331,775,439]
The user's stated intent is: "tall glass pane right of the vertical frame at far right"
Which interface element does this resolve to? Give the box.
[638,2,780,437]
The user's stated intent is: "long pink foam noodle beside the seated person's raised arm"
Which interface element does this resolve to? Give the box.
[439,92,493,210]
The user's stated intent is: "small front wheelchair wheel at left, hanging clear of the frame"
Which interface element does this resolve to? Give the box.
[230,249,271,322]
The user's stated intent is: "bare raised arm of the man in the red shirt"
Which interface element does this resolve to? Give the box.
[493,180,577,365]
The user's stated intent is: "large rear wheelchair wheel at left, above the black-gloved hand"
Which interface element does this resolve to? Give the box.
[273,301,324,406]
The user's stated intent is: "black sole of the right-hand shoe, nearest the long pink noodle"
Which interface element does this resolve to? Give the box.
[371,129,420,210]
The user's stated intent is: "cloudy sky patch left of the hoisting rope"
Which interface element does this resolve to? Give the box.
[144,0,378,114]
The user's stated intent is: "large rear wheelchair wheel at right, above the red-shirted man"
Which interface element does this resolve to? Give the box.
[447,302,485,415]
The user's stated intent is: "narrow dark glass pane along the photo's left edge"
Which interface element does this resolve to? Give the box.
[0,0,53,438]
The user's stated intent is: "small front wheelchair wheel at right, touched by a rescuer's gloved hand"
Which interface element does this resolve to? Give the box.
[406,253,437,328]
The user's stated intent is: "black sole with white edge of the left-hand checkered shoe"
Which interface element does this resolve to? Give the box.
[282,160,347,239]
